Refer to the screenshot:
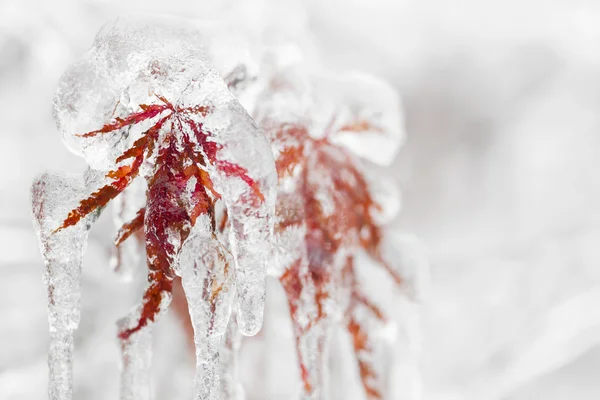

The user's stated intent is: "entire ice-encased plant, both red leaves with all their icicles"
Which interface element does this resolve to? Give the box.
[33,14,422,400]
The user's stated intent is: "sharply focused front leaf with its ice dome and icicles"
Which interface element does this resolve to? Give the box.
[32,18,277,400]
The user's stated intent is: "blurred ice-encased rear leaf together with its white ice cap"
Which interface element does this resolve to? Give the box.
[255,68,403,399]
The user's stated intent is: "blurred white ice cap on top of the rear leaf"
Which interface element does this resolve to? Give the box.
[248,64,405,166]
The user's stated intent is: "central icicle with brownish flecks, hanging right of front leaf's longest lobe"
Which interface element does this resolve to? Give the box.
[178,223,234,400]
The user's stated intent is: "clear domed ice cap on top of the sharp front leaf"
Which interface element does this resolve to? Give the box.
[54,16,208,170]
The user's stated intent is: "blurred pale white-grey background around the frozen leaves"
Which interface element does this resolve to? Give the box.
[0,0,600,400]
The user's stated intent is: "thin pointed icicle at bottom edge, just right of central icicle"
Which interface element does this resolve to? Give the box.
[220,312,245,400]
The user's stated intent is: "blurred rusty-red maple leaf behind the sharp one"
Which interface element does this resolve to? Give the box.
[267,121,402,399]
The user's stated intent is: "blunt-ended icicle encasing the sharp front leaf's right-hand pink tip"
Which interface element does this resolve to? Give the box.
[204,98,277,336]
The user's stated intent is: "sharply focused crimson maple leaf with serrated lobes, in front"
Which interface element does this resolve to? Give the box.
[57,95,265,339]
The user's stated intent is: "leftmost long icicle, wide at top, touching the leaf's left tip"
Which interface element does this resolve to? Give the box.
[31,173,95,400]
